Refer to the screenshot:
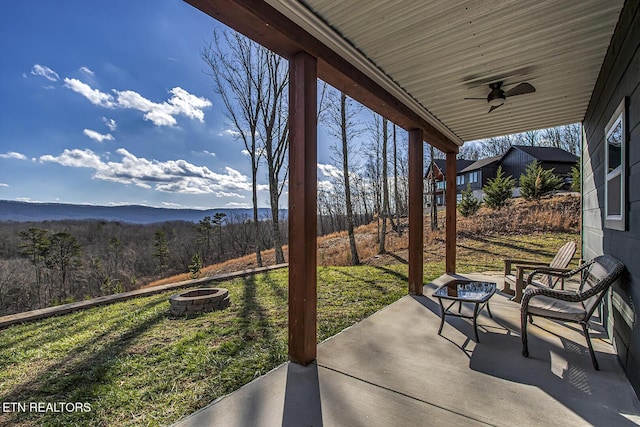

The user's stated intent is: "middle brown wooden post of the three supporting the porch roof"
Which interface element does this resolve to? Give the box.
[409,129,424,295]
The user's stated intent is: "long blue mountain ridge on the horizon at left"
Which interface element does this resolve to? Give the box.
[0,200,286,224]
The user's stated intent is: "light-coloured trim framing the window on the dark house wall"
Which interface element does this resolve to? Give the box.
[604,97,627,231]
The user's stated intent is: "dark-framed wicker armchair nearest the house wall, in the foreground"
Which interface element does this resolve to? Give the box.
[520,255,624,371]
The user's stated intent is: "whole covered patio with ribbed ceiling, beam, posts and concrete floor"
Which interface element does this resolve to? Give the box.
[178,0,640,426]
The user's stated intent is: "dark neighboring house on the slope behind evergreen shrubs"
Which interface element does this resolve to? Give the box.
[425,145,578,205]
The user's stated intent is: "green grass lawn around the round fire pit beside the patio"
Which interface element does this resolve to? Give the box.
[0,234,578,426]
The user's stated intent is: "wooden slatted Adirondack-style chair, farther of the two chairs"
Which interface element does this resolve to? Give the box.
[502,242,577,302]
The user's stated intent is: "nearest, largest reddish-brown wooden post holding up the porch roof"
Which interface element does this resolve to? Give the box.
[289,52,318,365]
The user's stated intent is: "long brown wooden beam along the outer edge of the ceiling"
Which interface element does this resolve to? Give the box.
[184,0,458,152]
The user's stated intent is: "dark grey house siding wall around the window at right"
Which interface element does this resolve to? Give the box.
[582,0,640,396]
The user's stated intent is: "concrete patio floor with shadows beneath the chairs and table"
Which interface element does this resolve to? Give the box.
[176,275,640,427]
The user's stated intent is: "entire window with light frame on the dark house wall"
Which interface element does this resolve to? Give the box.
[604,98,627,231]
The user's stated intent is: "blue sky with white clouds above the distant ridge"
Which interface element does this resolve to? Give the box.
[0,0,340,209]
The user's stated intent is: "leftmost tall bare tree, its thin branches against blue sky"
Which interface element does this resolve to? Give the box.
[201,31,267,266]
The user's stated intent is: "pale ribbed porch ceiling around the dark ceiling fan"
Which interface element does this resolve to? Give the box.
[267,0,624,144]
